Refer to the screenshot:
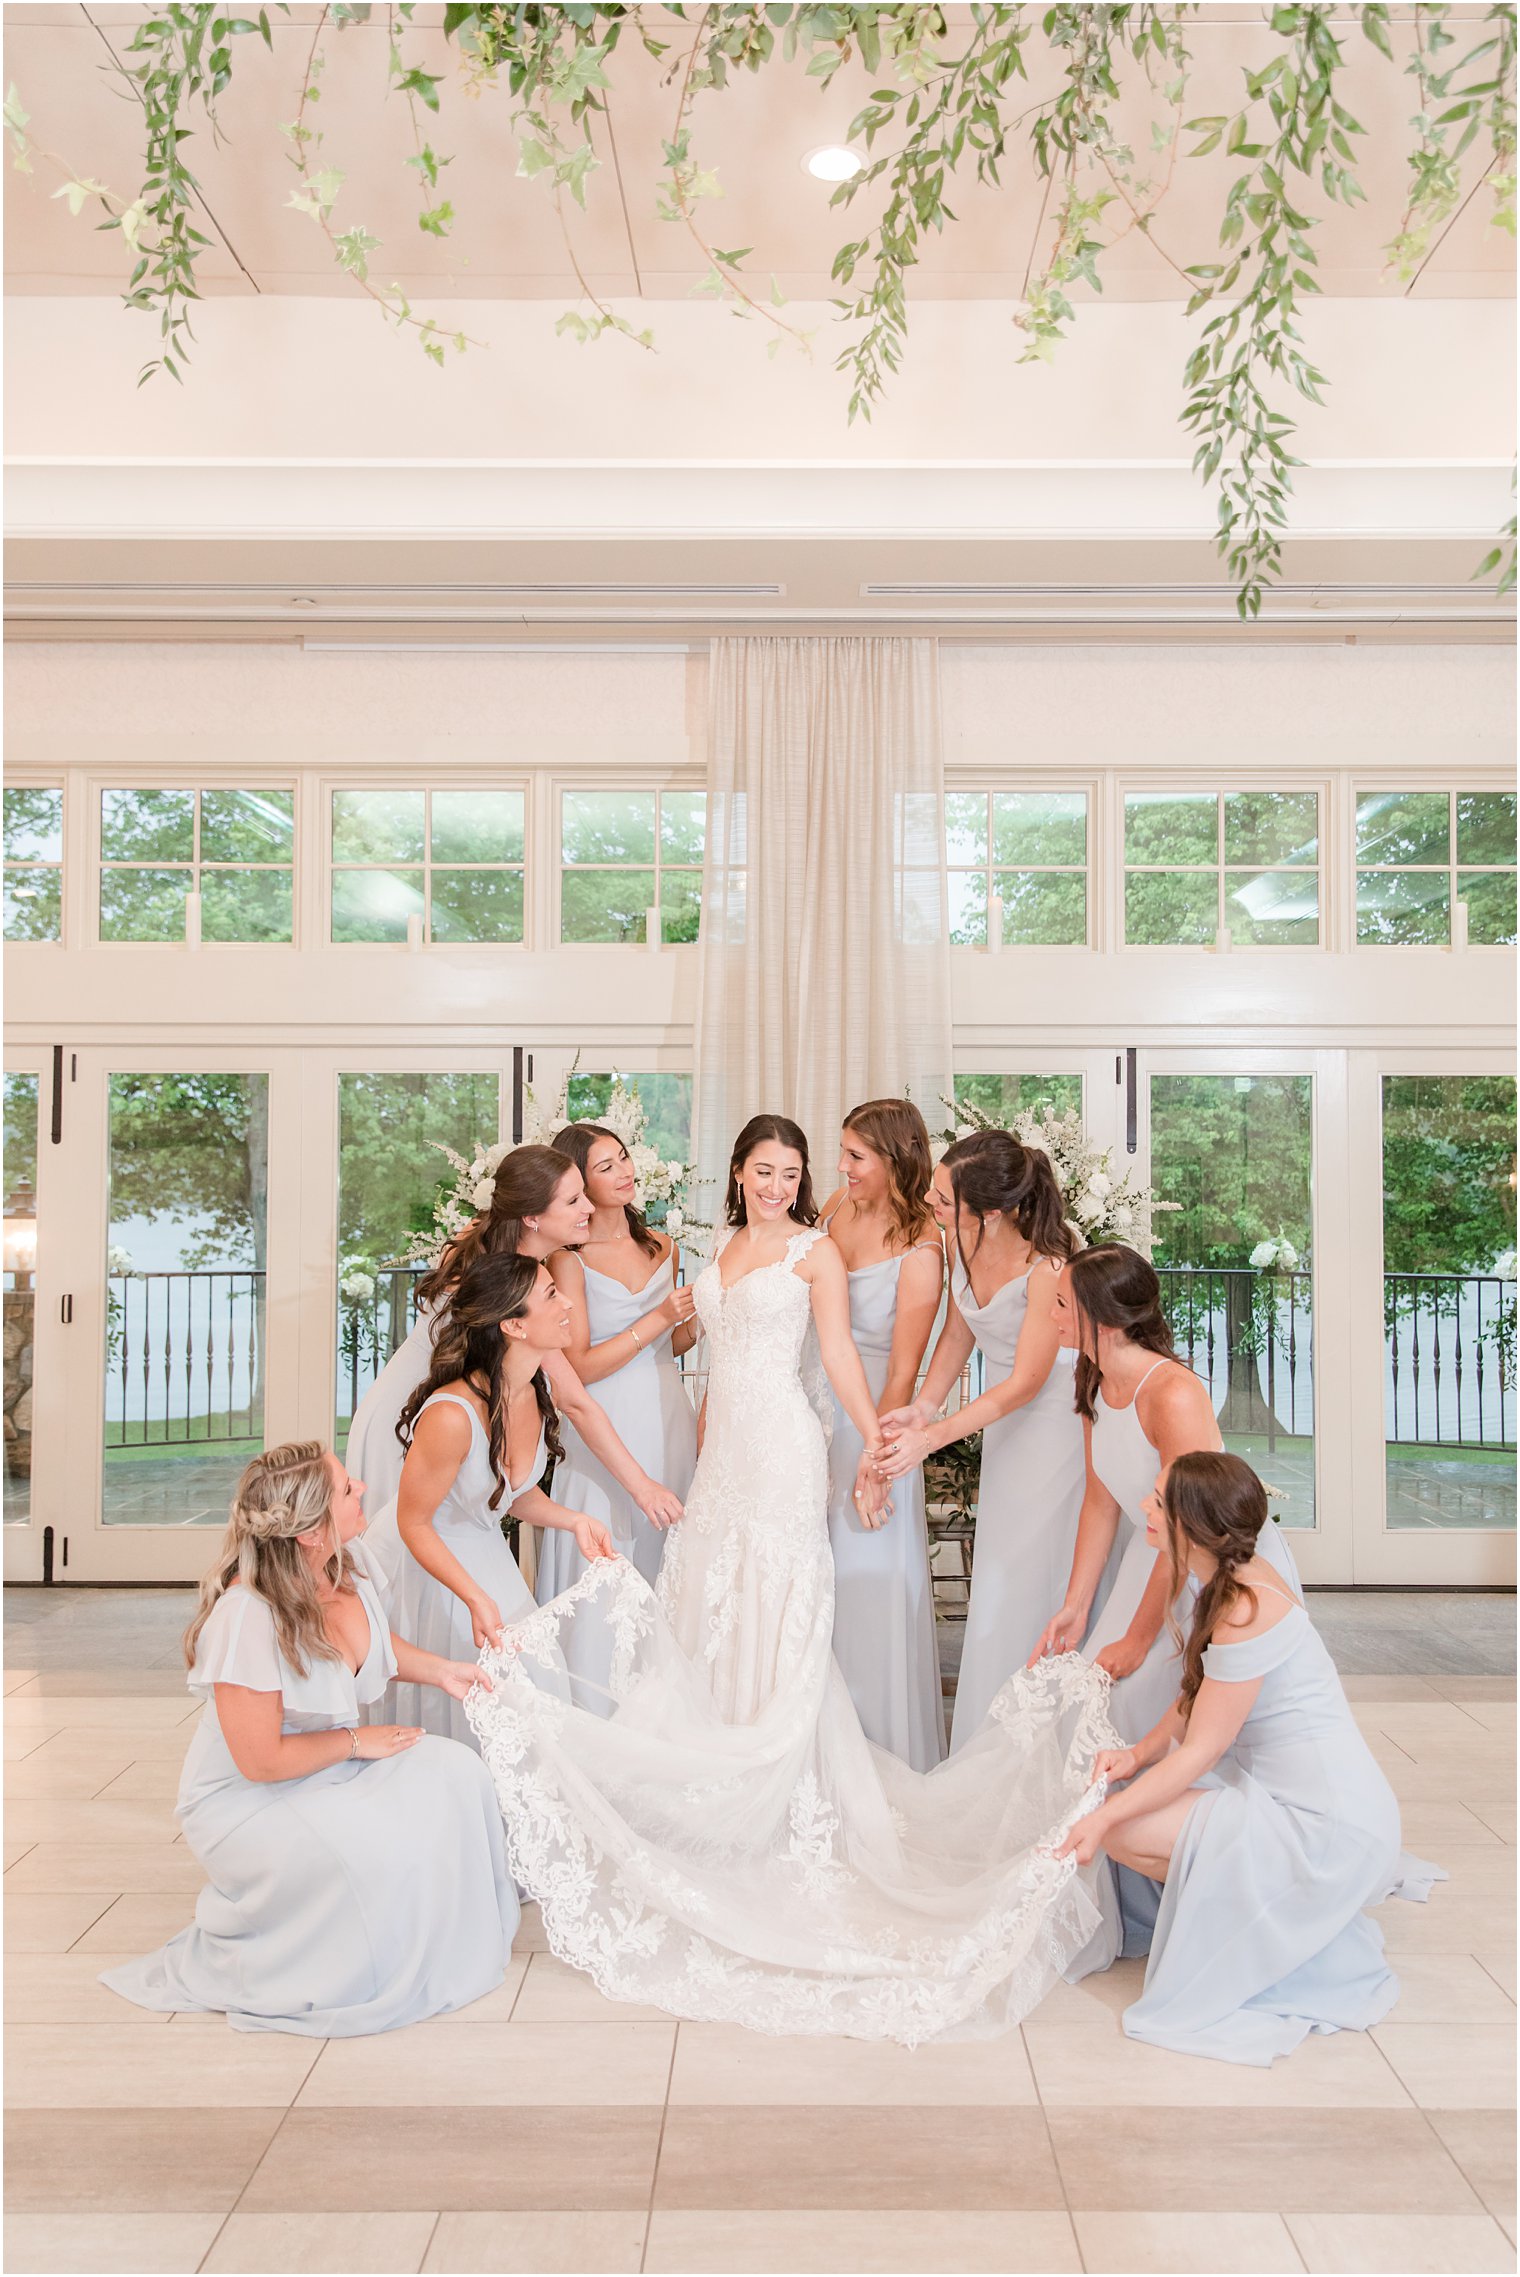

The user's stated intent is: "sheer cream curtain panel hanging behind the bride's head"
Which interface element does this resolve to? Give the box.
[696,640,951,1207]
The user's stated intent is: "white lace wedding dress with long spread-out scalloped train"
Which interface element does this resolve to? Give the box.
[466,1232,1117,2045]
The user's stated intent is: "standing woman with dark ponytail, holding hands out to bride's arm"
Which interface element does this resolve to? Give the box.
[881,1132,1083,1753]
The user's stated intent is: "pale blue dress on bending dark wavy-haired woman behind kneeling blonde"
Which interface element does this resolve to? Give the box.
[366,1391,546,1746]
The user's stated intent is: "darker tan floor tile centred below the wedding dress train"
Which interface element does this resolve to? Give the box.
[655,2104,1063,2213]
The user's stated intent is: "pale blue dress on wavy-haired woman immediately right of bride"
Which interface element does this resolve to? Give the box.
[828,1241,944,1772]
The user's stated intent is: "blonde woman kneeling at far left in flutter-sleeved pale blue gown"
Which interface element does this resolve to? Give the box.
[102,1439,517,2040]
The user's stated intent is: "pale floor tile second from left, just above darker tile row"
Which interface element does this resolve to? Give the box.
[300,2022,676,2109]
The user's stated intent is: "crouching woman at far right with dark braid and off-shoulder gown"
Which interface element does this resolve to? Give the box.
[1058,1453,1445,2065]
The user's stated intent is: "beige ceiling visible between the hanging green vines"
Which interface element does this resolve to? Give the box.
[5,0,1513,301]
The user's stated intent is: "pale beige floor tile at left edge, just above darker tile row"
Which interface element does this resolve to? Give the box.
[5,2022,320,2111]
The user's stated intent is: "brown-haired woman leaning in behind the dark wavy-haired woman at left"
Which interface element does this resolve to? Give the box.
[346,1145,680,1532]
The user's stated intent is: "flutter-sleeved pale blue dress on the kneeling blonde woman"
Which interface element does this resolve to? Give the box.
[100,1544,519,2040]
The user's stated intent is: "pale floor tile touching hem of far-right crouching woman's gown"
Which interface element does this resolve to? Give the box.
[1024,2022,1409,2111]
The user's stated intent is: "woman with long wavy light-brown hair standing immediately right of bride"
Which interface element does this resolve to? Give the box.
[821,1100,944,1772]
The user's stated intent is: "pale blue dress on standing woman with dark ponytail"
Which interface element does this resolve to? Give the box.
[951,1259,1088,1753]
